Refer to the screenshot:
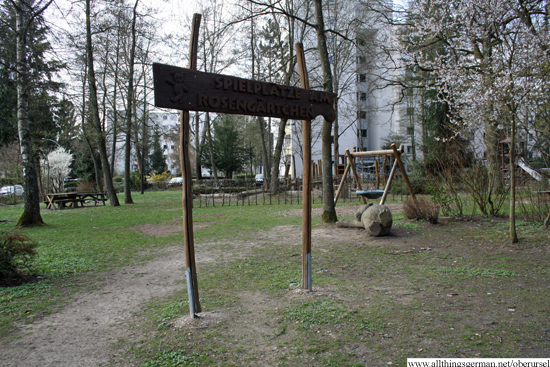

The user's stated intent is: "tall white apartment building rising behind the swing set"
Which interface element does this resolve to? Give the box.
[281,1,421,177]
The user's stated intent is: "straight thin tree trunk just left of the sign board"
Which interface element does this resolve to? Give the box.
[124,0,139,204]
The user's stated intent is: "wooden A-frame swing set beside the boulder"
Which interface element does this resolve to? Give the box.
[334,144,416,205]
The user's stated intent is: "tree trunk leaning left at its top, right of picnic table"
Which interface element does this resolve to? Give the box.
[86,0,120,206]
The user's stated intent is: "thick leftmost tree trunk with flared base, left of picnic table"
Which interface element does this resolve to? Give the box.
[15,0,45,227]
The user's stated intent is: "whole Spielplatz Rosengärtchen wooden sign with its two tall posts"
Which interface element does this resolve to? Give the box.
[153,14,336,317]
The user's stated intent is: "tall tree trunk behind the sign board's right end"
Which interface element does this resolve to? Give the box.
[314,0,338,223]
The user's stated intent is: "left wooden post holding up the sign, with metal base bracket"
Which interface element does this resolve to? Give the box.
[180,14,202,318]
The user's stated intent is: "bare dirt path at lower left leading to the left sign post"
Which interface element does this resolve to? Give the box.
[0,248,185,367]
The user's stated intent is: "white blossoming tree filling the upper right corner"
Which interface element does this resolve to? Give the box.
[403,0,550,242]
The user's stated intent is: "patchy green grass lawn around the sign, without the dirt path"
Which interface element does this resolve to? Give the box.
[0,191,550,366]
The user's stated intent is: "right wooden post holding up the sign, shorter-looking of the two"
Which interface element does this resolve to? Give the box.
[295,43,312,292]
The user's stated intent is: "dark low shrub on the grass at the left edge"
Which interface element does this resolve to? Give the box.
[0,230,36,279]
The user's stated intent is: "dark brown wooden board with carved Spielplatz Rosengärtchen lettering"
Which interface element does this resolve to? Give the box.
[153,64,336,122]
